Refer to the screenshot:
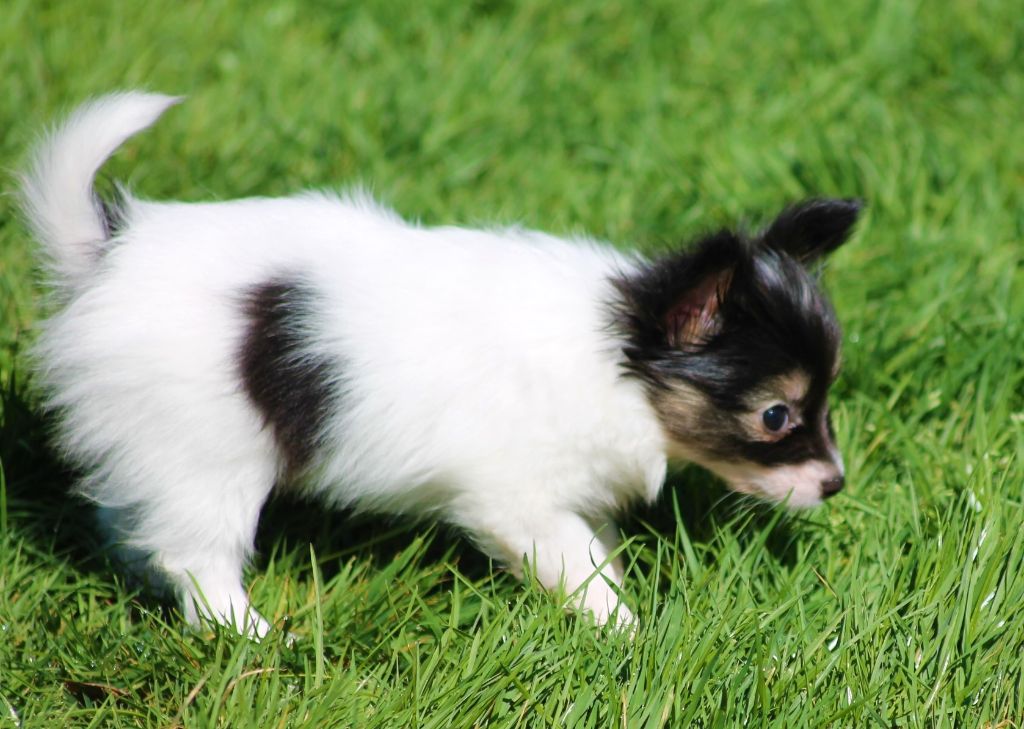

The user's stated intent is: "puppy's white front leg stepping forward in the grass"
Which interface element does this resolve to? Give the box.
[471,511,634,627]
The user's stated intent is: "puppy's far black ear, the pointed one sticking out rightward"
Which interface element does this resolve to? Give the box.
[759,199,863,263]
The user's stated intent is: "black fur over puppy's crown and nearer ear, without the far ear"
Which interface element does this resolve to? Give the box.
[615,233,840,401]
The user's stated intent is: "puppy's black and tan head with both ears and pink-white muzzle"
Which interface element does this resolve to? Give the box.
[616,200,860,507]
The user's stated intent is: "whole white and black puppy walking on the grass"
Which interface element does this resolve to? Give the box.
[23,92,859,635]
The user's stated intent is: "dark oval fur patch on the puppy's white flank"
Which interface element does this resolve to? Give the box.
[239,278,337,475]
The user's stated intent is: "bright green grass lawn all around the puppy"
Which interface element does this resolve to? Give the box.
[0,0,1024,727]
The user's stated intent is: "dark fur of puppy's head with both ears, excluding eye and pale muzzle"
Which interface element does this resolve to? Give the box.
[612,201,859,466]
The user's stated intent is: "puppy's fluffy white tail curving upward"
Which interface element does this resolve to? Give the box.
[22,91,181,289]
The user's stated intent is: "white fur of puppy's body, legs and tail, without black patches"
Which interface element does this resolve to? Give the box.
[25,93,667,635]
